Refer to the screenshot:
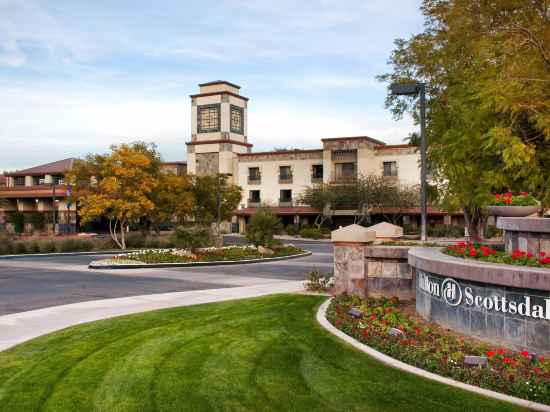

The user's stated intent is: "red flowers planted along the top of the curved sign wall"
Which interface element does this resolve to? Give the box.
[443,242,550,269]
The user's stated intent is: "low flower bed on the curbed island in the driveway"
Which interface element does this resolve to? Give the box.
[92,246,305,266]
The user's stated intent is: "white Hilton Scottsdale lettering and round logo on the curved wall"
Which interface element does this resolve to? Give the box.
[417,271,550,320]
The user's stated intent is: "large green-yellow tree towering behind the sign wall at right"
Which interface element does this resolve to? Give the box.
[379,0,550,237]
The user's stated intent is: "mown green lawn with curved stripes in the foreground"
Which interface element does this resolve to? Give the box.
[0,295,528,412]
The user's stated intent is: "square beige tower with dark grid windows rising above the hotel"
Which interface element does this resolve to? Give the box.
[187,80,252,178]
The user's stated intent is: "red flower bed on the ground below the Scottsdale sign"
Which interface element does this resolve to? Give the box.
[327,295,550,404]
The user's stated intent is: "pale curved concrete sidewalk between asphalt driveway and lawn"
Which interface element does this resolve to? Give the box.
[0,281,304,351]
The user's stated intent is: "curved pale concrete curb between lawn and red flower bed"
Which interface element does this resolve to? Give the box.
[317,298,550,412]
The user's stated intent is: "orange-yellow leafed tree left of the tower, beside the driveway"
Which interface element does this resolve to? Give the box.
[67,142,162,249]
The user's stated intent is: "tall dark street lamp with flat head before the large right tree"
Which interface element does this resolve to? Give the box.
[390,82,428,241]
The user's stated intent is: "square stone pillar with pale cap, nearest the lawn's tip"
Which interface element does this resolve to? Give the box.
[331,224,376,297]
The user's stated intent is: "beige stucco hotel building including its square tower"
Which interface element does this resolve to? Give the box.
[187,81,432,231]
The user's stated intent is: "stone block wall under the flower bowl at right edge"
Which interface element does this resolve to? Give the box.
[497,217,550,256]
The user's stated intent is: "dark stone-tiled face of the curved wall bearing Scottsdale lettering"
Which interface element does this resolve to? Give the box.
[415,269,550,353]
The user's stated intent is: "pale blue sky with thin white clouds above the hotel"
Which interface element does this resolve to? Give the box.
[0,0,423,170]
